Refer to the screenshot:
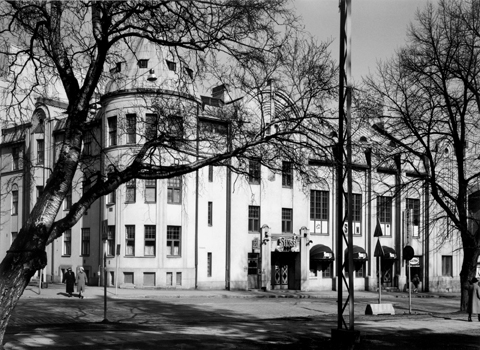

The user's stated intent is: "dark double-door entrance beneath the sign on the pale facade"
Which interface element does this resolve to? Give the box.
[272,252,300,289]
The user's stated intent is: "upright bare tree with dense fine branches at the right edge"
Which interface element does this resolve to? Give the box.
[364,0,480,310]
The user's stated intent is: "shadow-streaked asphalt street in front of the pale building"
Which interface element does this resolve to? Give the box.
[4,285,480,350]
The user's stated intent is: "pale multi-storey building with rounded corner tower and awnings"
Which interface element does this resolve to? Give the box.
[0,42,470,291]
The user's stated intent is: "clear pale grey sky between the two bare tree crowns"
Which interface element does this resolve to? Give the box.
[294,0,437,82]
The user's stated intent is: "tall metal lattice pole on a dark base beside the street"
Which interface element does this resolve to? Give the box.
[332,0,360,345]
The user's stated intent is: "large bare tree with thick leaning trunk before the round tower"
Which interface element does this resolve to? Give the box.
[0,0,335,342]
